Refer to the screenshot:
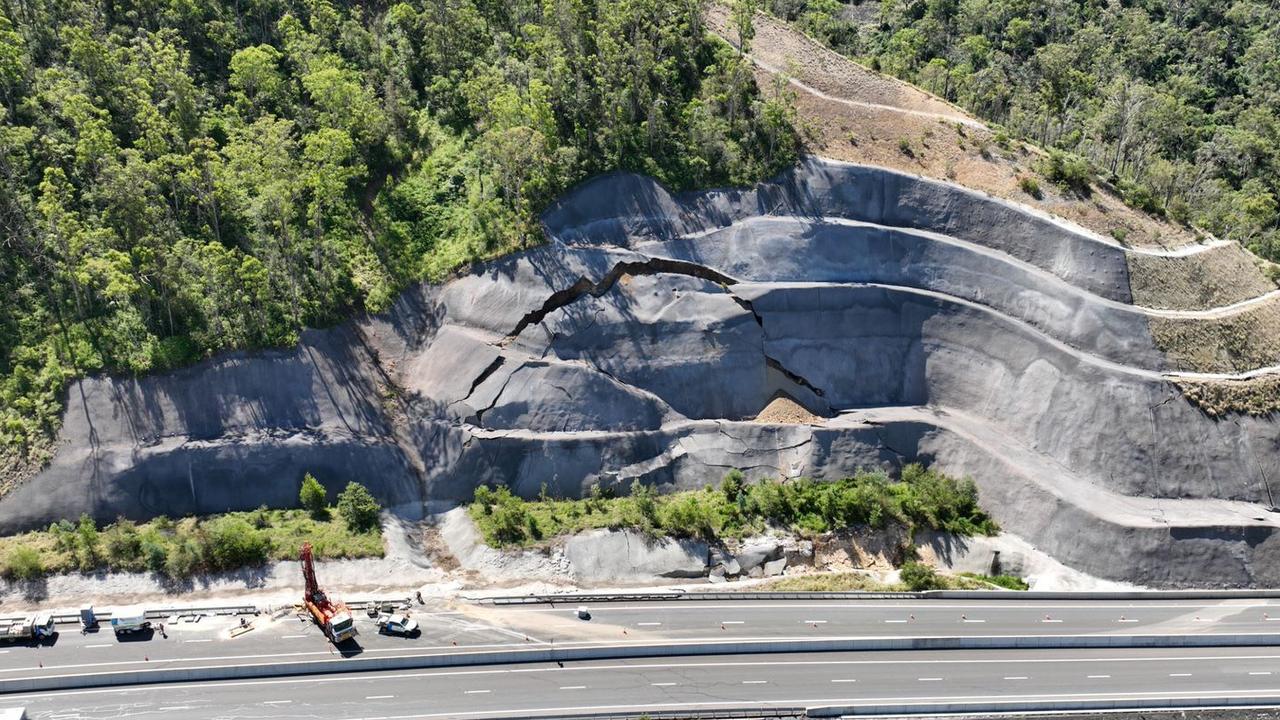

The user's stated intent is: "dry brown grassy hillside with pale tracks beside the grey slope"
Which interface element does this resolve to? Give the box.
[708,0,1280,404]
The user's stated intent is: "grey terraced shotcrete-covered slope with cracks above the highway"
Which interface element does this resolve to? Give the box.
[10,159,1280,585]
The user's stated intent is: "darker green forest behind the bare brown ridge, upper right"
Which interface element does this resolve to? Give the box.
[764,0,1280,260]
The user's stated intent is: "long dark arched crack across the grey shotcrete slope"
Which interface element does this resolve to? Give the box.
[488,258,832,414]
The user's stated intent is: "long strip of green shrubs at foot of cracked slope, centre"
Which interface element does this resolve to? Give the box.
[468,465,997,547]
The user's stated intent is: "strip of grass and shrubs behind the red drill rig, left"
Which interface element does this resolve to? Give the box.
[0,507,383,580]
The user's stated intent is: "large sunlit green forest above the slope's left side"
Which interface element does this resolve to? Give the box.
[0,0,799,470]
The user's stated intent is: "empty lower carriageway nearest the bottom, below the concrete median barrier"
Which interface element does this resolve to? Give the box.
[17,648,1280,720]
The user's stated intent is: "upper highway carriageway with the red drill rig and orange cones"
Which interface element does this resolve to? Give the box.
[0,600,1280,679]
